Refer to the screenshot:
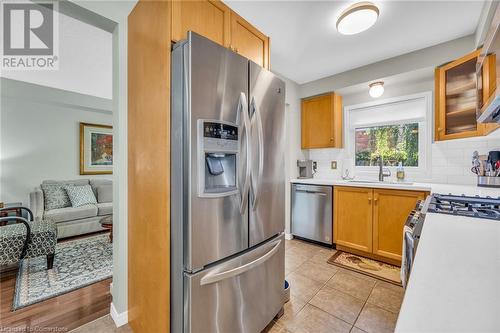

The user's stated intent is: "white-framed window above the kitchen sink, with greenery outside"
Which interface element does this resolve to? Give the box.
[345,92,432,178]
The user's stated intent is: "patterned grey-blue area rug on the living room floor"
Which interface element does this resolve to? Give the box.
[12,233,113,310]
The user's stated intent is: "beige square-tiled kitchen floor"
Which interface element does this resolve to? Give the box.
[72,240,403,333]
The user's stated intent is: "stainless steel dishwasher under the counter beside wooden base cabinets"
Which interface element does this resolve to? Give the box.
[291,184,333,245]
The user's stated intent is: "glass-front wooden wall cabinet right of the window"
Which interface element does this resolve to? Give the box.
[435,50,497,141]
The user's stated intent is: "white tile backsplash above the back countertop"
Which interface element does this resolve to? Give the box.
[309,130,500,185]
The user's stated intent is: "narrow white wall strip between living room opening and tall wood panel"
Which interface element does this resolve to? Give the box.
[67,0,137,324]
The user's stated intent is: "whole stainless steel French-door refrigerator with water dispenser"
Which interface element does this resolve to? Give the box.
[171,32,285,333]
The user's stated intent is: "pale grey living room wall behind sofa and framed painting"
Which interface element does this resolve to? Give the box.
[0,79,113,206]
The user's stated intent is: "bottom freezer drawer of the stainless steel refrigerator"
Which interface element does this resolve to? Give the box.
[184,234,285,333]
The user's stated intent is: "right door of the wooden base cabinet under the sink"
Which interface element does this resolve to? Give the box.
[372,189,426,261]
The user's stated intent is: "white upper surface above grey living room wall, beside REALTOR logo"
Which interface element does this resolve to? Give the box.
[1,9,113,99]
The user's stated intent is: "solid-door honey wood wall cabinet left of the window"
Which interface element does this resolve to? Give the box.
[301,92,342,149]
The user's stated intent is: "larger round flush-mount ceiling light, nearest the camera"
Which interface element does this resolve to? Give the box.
[337,2,379,35]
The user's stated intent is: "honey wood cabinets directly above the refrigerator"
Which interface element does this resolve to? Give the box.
[172,0,270,69]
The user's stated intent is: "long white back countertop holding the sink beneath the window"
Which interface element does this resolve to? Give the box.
[290,178,500,197]
